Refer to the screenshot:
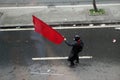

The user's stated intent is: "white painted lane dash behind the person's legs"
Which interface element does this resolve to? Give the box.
[32,56,93,60]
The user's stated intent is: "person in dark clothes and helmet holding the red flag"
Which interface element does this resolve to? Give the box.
[64,35,84,67]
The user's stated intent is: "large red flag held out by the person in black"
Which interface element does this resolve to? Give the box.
[32,16,64,44]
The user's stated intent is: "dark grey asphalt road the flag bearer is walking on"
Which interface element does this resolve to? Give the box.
[0,28,120,80]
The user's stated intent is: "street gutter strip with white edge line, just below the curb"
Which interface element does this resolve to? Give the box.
[0,24,120,31]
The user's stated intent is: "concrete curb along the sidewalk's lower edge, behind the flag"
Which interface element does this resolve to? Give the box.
[0,20,120,28]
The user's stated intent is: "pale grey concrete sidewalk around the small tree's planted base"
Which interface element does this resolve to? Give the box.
[0,4,120,27]
